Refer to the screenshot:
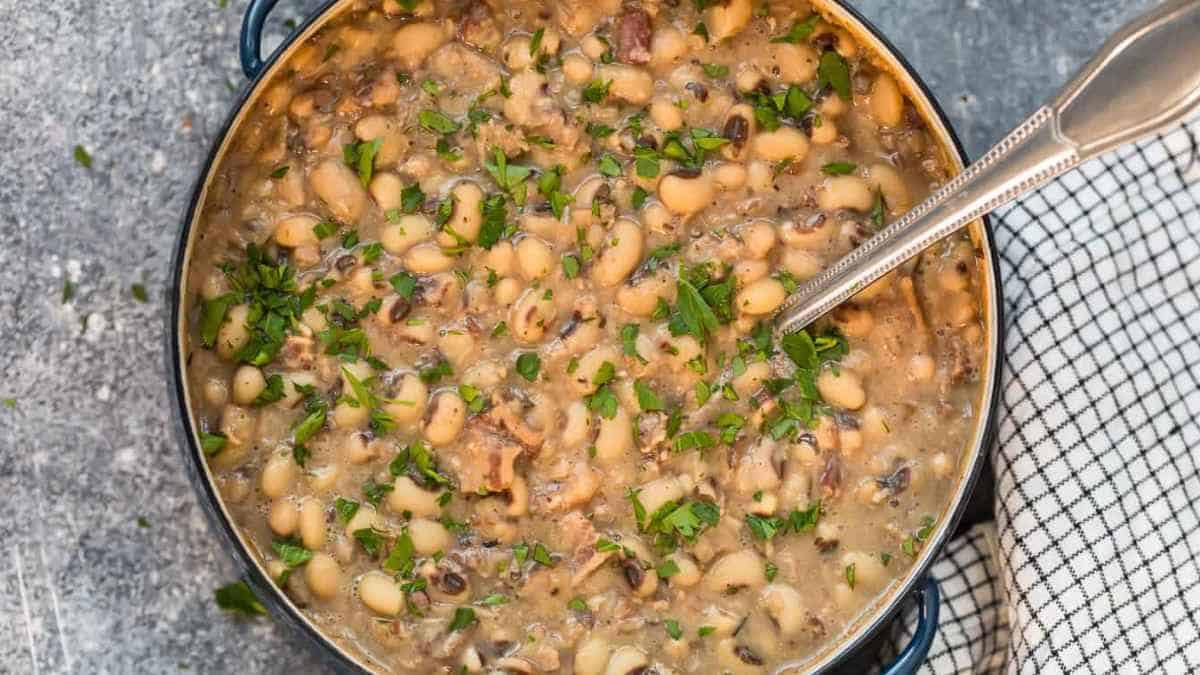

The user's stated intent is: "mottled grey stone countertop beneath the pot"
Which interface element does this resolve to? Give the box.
[0,0,1153,673]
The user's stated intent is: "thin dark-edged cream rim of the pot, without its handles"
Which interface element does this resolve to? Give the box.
[164,0,1004,673]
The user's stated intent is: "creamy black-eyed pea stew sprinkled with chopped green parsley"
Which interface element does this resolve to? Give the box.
[185,0,984,675]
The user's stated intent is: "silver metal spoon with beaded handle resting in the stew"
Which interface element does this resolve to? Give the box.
[775,0,1200,335]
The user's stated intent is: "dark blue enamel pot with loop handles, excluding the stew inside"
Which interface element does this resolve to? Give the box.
[166,0,1002,675]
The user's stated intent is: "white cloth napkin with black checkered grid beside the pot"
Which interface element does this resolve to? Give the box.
[873,119,1200,675]
